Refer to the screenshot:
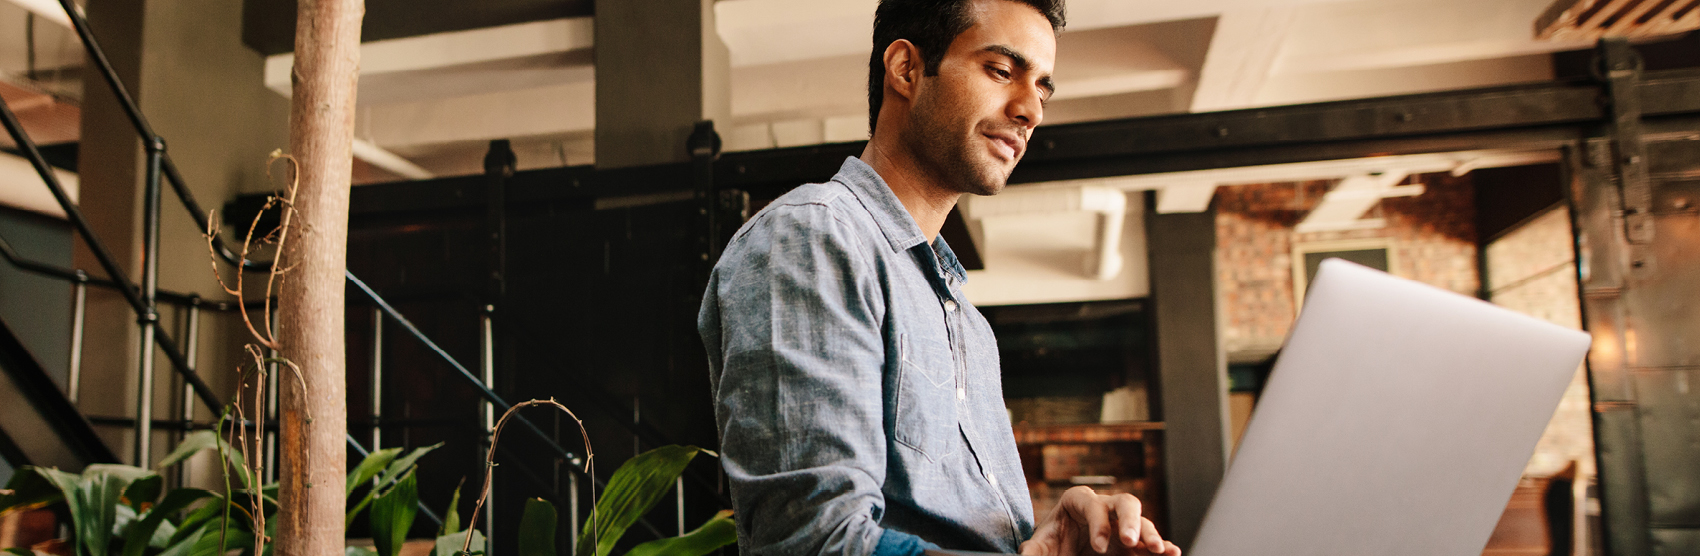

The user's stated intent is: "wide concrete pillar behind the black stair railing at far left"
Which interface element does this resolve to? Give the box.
[73,0,289,469]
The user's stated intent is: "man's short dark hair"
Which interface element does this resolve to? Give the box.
[867,0,1064,136]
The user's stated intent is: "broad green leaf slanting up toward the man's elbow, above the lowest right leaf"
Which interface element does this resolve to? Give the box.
[573,444,702,556]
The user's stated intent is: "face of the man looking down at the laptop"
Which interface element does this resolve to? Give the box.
[904,0,1056,196]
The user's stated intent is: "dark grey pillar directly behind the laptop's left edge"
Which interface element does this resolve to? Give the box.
[1146,211,1229,549]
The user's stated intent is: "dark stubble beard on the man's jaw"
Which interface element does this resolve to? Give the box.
[908,87,1010,196]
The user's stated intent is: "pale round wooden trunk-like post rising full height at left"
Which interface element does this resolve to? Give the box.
[277,0,366,556]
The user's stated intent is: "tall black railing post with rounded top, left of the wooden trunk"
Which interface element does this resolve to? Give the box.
[133,136,165,468]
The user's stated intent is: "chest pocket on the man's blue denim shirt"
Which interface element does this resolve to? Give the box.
[893,335,961,461]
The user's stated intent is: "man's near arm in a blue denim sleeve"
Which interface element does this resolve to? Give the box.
[700,204,930,554]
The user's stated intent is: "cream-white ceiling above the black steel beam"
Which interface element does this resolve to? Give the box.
[0,0,1611,179]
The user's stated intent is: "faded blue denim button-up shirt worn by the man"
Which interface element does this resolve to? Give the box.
[697,158,1034,556]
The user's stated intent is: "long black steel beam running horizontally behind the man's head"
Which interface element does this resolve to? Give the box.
[261,70,1700,224]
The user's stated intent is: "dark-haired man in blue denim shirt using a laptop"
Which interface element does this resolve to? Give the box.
[699,0,1180,556]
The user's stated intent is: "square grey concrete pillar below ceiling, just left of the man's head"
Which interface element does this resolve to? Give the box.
[595,0,731,168]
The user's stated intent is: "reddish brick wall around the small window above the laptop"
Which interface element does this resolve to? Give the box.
[1216,173,1479,362]
